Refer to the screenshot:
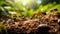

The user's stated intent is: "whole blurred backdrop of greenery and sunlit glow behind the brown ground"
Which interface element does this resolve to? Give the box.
[0,0,60,34]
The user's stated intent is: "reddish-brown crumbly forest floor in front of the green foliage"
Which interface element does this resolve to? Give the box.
[0,14,60,34]
